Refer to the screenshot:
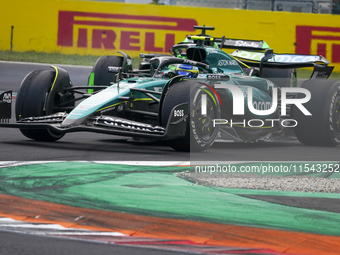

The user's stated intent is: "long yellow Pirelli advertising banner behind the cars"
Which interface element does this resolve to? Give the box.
[0,0,340,72]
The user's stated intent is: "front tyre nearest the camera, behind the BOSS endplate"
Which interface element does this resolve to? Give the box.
[161,80,220,152]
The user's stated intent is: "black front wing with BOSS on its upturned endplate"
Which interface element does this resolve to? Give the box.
[0,97,189,140]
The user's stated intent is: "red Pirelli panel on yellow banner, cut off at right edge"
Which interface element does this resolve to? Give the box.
[295,26,340,63]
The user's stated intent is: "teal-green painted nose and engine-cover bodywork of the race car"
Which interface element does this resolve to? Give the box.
[62,46,276,129]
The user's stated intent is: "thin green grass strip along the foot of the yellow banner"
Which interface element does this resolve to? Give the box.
[0,50,340,79]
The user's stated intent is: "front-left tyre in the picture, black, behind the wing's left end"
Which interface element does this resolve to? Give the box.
[15,67,74,141]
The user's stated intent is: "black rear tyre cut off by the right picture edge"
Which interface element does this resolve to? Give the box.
[292,79,340,146]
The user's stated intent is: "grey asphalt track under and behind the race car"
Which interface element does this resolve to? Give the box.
[0,61,340,161]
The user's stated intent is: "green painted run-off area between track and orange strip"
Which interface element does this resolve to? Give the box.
[0,162,340,235]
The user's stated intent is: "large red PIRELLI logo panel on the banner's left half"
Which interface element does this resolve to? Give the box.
[58,11,197,52]
